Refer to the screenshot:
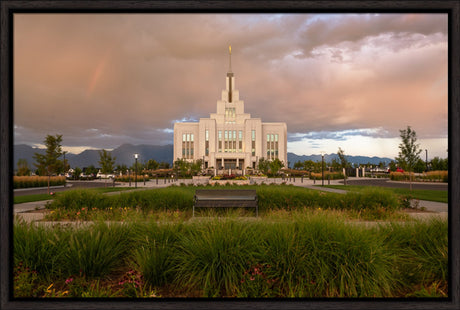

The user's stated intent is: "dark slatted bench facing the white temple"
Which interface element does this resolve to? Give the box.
[193,189,259,216]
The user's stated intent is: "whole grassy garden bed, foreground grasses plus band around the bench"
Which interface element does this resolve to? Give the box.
[13,185,448,298]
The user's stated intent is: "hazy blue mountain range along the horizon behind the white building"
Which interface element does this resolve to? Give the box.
[14,144,392,168]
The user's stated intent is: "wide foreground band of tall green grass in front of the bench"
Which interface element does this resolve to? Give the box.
[13,210,448,297]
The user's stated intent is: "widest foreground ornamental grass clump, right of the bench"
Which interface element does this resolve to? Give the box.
[261,213,393,297]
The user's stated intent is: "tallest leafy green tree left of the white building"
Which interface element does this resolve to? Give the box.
[33,135,63,194]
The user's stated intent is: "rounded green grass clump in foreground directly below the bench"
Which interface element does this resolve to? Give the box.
[173,220,260,297]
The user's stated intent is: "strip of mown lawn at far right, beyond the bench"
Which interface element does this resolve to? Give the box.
[324,185,448,203]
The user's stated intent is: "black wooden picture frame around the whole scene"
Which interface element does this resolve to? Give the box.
[0,0,460,310]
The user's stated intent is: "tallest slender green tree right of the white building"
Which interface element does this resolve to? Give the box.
[396,126,422,190]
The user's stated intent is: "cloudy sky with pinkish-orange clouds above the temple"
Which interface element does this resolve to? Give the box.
[14,14,448,158]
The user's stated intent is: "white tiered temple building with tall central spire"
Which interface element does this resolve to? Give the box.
[174,47,287,170]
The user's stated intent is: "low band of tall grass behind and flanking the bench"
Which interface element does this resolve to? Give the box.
[49,185,402,219]
